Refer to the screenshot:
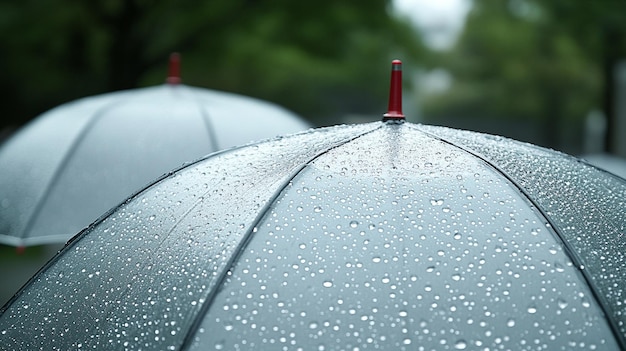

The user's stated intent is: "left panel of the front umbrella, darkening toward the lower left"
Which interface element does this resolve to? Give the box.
[0,125,376,350]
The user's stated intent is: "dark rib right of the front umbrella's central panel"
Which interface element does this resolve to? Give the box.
[412,127,626,350]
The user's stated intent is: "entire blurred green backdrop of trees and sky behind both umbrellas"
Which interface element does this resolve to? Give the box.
[0,0,626,305]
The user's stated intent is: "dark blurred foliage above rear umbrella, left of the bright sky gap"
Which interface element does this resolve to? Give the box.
[0,0,424,129]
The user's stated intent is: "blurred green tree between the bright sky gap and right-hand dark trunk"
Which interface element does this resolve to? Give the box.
[416,0,626,153]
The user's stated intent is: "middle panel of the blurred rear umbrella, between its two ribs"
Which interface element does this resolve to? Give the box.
[27,103,212,241]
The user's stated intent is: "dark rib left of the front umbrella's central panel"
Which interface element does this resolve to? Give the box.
[180,124,384,350]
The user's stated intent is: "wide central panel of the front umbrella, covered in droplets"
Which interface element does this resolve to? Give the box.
[192,128,618,350]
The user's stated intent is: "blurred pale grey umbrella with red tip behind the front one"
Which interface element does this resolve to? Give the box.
[0,55,309,246]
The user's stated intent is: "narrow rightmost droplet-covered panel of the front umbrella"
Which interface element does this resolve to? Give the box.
[420,126,626,335]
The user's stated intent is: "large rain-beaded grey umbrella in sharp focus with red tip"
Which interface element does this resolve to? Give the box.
[0,61,626,350]
